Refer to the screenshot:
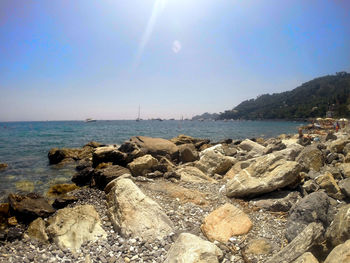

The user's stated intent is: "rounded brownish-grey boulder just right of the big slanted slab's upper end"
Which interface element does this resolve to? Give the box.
[296,146,324,171]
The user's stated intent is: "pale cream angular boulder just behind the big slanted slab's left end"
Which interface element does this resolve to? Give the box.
[195,145,236,176]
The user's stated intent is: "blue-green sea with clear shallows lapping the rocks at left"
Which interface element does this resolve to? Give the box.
[0,120,305,201]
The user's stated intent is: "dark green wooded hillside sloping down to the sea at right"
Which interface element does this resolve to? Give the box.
[218,72,350,119]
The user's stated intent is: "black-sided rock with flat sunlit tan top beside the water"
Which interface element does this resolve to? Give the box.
[92,146,127,167]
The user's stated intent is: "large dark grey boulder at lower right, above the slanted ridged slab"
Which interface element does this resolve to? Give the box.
[285,192,330,241]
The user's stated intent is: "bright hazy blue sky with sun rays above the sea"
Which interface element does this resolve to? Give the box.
[0,0,350,121]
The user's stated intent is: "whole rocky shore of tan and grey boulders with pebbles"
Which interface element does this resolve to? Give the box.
[0,133,350,263]
